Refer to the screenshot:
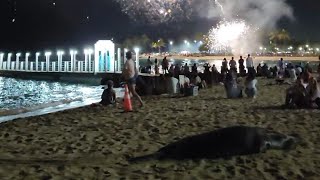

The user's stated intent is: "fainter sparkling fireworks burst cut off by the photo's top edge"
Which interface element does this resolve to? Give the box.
[114,0,192,24]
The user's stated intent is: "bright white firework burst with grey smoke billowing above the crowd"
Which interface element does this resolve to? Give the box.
[198,0,293,54]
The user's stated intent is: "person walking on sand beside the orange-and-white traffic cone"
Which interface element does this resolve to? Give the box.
[122,51,143,107]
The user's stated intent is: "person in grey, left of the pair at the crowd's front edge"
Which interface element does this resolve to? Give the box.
[224,71,243,99]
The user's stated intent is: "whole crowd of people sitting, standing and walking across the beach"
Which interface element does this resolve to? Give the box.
[97,52,320,108]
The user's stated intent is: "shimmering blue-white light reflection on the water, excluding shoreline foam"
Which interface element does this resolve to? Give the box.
[0,77,102,109]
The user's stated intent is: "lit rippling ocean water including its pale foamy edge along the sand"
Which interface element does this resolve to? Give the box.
[0,77,123,122]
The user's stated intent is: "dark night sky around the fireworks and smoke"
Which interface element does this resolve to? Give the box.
[0,0,320,50]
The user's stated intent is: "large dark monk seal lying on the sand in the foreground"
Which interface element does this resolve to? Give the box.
[129,126,296,161]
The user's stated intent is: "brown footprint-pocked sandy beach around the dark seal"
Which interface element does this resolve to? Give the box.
[0,79,320,180]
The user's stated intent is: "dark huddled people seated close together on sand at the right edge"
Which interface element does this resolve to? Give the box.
[285,71,320,108]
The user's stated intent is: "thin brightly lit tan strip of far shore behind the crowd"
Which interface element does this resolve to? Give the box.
[140,55,319,62]
